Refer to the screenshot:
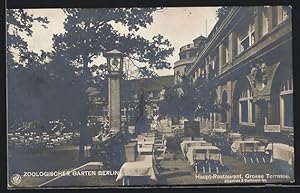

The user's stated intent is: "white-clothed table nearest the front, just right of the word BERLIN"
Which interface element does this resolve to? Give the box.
[116,155,158,185]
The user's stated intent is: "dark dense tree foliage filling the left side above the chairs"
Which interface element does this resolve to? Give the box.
[7,9,92,132]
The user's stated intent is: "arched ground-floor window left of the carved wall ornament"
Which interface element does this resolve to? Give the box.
[239,83,255,125]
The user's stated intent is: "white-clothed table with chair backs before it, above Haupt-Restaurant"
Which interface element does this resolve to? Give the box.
[186,145,223,166]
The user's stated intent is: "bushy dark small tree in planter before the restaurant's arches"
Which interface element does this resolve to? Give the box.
[159,75,228,121]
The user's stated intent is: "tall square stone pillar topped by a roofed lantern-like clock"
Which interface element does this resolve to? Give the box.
[105,49,123,133]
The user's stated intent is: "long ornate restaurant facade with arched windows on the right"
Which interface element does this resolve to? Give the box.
[182,6,294,142]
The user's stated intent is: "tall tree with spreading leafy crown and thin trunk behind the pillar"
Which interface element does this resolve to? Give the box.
[53,8,174,163]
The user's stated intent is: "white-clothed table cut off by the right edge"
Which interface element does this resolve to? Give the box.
[266,143,294,165]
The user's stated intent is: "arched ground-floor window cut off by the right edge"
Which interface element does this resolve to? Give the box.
[280,77,294,128]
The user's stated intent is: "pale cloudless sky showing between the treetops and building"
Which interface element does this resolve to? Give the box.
[26,7,218,76]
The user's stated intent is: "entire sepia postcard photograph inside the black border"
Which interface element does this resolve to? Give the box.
[6,5,295,189]
